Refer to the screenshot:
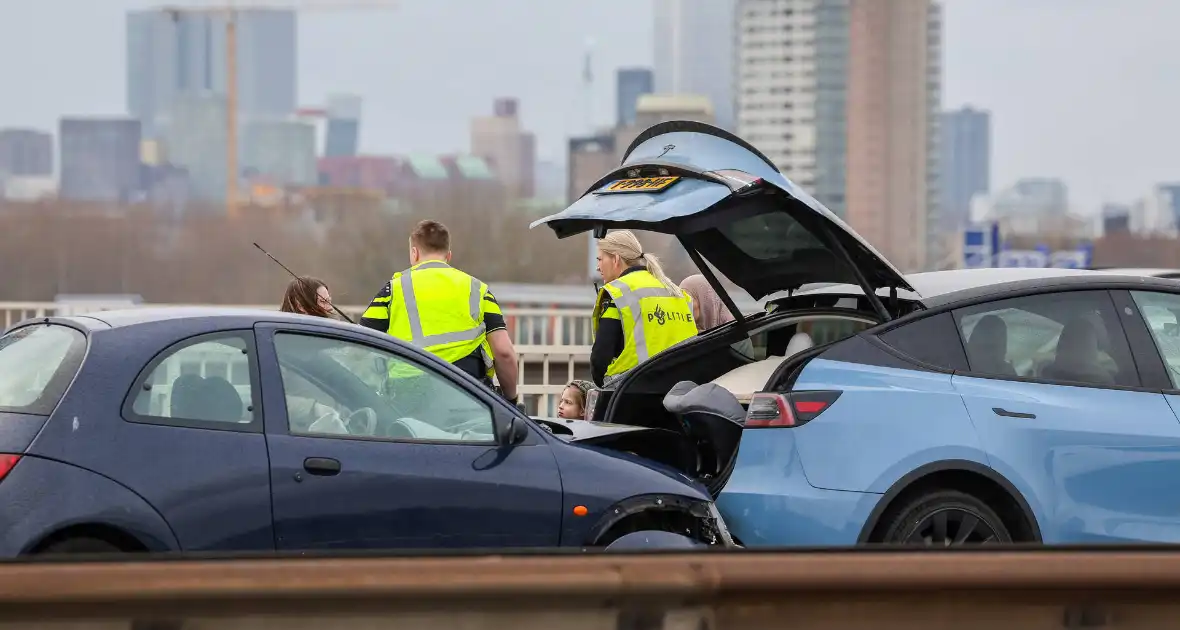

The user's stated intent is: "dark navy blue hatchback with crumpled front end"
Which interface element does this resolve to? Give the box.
[0,308,732,557]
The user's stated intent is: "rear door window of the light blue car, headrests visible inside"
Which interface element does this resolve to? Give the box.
[955,291,1139,386]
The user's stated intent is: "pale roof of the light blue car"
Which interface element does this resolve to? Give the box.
[771,268,1176,308]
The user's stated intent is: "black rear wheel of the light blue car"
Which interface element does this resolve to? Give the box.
[880,490,1012,546]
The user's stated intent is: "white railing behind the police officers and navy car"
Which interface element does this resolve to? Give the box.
[0,302,592,415]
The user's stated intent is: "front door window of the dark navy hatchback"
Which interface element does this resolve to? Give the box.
[275,333,496,444]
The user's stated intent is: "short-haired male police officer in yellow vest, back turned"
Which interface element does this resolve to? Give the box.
[360,221,519,415]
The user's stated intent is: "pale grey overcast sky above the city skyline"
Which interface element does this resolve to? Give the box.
[0,0,1180,211]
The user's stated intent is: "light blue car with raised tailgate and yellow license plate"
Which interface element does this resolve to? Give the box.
[533,122,1180,546]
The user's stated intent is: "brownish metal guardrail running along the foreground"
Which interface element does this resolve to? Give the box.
[0,550,1180,630]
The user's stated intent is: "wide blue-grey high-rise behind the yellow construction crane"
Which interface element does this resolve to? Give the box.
[127,8,297,138]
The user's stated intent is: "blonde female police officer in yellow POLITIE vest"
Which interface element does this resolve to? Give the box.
[590,230,696,387]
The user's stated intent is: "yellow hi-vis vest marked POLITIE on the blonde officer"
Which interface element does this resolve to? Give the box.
[591,269,696,376]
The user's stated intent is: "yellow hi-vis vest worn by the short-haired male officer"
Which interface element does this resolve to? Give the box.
[372,261,496,379]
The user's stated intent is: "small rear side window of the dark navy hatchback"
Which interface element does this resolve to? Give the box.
[131,333,255,426]
